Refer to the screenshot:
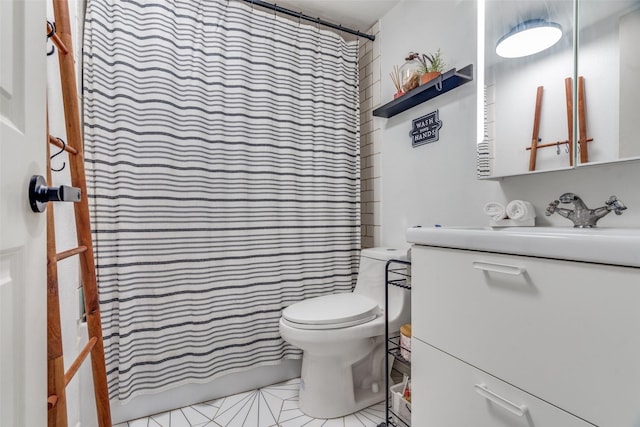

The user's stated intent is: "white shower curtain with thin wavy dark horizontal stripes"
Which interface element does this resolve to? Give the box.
[83,0,360,401]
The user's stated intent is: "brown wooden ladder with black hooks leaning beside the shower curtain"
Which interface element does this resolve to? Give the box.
[47,0,112,427]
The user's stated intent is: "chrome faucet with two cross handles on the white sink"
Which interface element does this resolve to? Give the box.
[545,193,627,228]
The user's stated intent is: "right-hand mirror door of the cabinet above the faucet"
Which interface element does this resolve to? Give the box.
[577,0,640,166]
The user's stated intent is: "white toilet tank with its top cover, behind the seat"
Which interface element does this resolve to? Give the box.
[353,248,407,308]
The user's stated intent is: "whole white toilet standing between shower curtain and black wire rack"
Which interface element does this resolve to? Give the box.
[280,248,411,418]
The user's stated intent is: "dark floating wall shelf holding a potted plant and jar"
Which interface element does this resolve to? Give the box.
[373,64,473,118]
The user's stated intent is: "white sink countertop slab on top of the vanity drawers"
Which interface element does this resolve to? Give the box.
[407,226,640,267]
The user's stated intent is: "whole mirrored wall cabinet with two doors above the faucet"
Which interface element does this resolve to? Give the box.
[478,0,640,178]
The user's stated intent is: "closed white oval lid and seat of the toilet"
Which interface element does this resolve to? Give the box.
[282,292,380,329]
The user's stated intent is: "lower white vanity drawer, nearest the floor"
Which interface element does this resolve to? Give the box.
[411,340,592,427]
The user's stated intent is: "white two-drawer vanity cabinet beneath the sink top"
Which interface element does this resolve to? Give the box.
[412,245,640,427]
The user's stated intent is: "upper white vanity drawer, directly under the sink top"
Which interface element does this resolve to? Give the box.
[412,246,640,426]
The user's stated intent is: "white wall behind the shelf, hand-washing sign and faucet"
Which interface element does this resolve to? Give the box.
[375,0,640,247]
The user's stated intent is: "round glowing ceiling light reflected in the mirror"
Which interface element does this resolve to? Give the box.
[496,19,562,58]
